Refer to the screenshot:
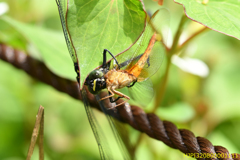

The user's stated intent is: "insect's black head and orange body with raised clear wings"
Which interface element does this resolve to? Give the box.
[85,9,169,107]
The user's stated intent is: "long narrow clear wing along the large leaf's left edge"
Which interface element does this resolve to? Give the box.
[56,0,78,63]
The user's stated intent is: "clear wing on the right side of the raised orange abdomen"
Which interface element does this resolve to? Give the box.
[127,9,170,82]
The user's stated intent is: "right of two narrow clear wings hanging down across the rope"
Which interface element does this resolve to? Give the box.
[95,95,132,160]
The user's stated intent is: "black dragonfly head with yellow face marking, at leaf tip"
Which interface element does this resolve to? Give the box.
[85,69,106,94]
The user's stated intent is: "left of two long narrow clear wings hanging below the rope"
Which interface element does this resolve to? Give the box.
[81,87,113,160]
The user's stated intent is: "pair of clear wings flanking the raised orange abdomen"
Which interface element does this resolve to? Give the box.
[117,9,170,81]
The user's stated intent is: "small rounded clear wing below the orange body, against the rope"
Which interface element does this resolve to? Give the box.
[129,79,154,106]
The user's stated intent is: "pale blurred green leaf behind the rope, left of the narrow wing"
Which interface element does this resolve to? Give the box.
[0,16,76,80]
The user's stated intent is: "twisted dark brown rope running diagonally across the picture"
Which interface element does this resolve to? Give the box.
[0,44,240,160]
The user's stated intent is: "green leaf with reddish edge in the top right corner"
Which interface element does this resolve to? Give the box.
[175,0,240,39]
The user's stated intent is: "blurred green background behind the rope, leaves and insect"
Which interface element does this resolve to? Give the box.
[0,0,240,160]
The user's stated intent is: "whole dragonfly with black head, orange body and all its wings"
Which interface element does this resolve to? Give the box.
[56,0,170,159]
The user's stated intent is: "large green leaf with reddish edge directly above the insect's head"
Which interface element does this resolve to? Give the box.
[67,0,146,86]
